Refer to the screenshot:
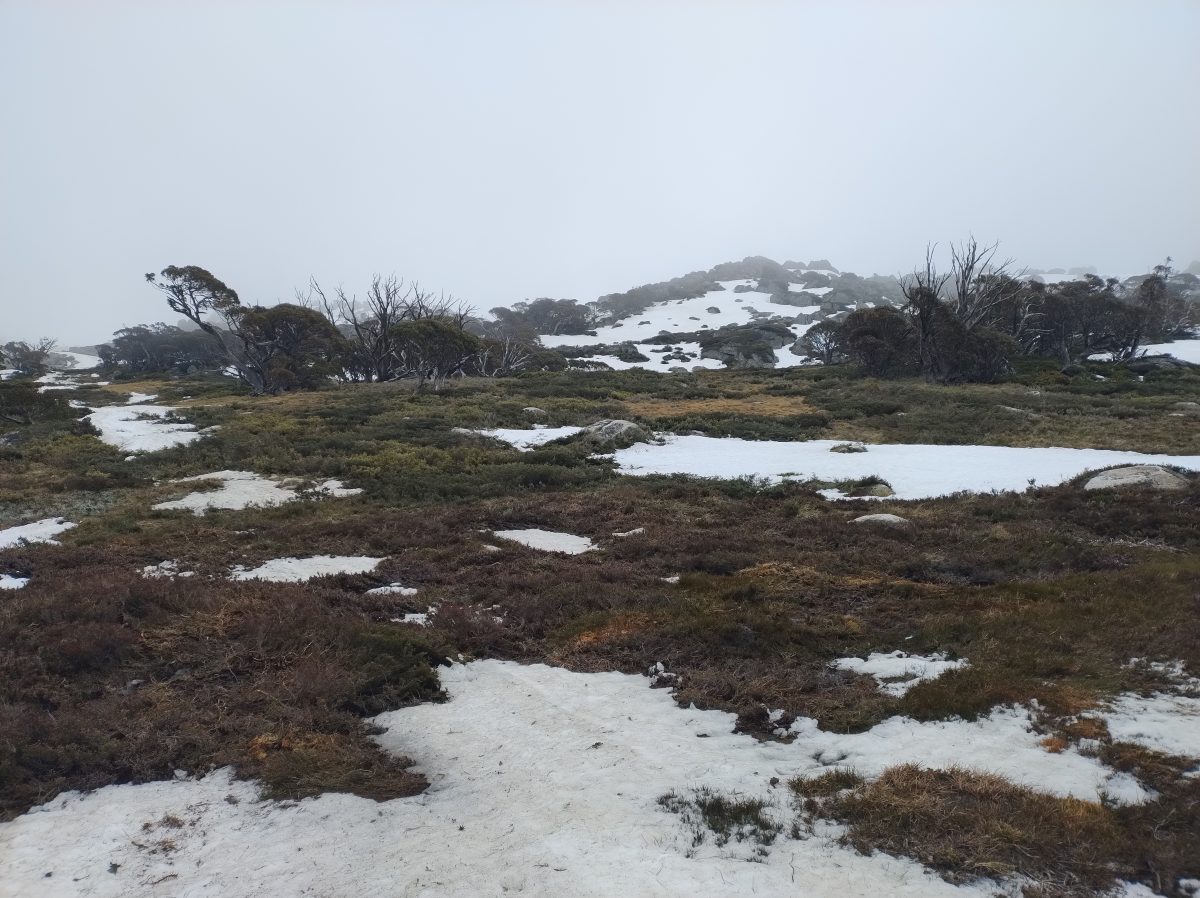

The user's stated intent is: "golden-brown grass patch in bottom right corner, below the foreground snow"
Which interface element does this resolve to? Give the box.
[792,765,1200,898]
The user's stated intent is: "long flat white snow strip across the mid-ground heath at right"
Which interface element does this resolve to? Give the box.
[613,436,1200,499]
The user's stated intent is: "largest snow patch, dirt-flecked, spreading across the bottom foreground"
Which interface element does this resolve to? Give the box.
[0,660,1152,898]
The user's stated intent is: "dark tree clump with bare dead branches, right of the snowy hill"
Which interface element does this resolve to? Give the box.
[800,240,1200,383]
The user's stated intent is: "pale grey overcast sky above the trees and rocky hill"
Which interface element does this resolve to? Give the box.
[0,0,1200,345]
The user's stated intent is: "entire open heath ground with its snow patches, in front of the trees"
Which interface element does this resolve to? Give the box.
[0,352,1200,898]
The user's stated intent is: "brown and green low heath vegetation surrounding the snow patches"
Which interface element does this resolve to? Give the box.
[0,363,1200,896]
